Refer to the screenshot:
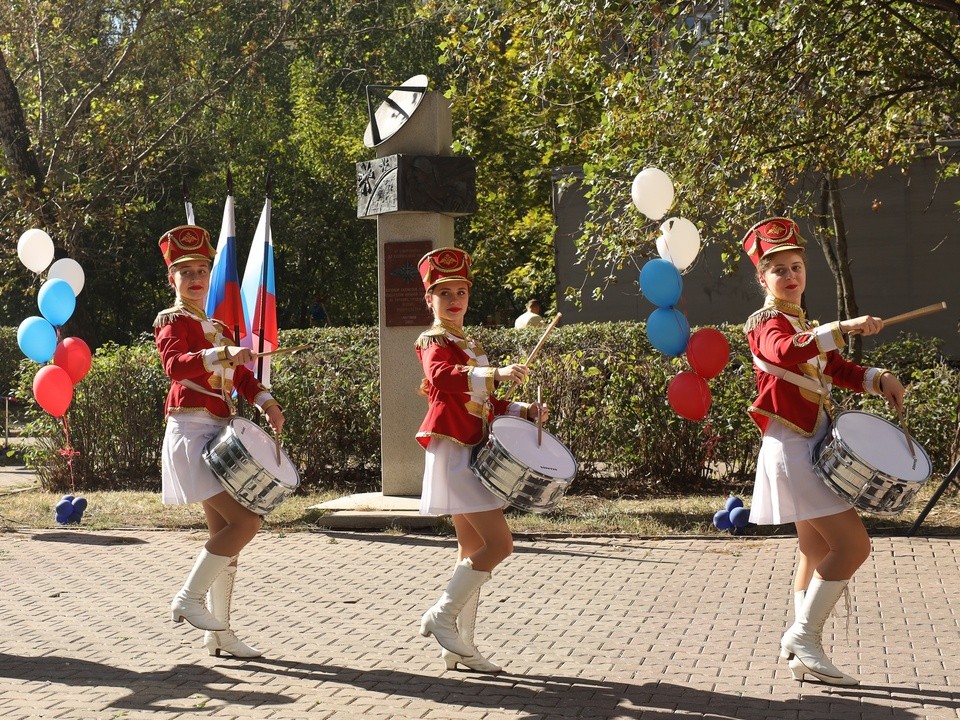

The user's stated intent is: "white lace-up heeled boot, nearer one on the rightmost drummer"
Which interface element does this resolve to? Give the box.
[780,577,859,685]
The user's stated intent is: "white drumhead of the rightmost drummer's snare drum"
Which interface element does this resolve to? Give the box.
[832,410,933,482]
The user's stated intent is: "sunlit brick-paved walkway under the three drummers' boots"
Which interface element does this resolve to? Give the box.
[0,529,960,720]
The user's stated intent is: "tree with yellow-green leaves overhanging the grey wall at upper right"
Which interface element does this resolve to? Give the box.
[437,0,960,340]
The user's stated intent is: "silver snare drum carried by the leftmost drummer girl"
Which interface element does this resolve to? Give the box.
[203,417,300,515]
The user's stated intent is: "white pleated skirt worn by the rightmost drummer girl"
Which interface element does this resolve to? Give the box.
[750,420,851,525]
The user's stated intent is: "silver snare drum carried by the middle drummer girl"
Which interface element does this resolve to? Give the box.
[470,415,577,513]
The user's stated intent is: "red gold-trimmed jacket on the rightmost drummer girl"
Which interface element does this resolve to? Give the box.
[744,299,884,437]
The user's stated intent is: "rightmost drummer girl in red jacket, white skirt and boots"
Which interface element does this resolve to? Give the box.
[743,217,904,685]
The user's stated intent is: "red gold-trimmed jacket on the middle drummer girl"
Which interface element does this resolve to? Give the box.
[417,325,529,447]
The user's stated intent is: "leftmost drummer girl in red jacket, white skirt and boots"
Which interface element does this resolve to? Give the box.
[153,225,283,657]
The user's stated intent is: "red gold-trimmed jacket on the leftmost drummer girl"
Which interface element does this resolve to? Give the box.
[153,304,277,418]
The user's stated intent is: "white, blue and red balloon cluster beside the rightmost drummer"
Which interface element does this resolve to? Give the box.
[630,168,730,422]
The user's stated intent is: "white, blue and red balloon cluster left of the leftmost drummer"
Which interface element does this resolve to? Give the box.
[17,228,92,418]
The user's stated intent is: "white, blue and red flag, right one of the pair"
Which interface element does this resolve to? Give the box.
[240,196,278,387]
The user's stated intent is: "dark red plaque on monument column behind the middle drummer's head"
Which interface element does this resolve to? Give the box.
[382,240,433,328]
